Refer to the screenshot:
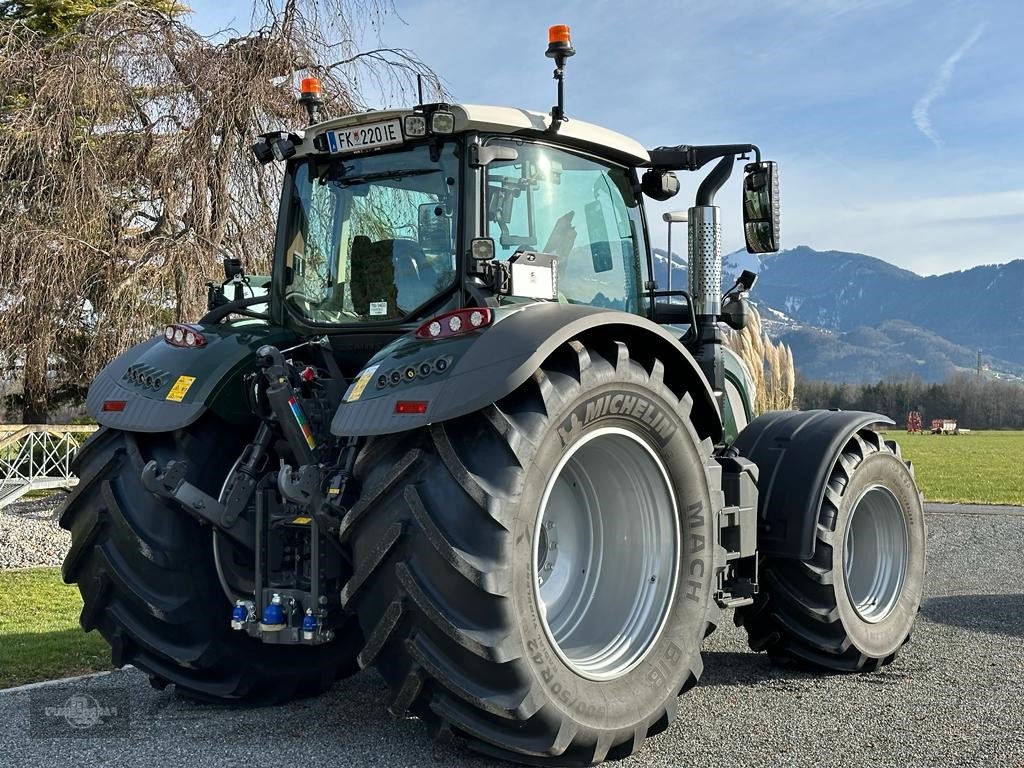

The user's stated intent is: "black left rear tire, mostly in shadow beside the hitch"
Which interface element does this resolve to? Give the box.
[59,426,361,705]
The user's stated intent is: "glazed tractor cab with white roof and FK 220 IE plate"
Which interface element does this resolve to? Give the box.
[257,104,650,331]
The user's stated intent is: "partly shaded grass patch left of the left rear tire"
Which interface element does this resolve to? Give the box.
[0,568,111,688]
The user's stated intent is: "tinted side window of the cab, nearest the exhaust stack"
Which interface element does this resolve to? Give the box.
[485,139,646,313]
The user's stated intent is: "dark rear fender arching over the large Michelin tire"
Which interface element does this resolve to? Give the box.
[331,303,722,442]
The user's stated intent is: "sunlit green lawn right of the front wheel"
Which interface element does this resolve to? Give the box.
[887,431,1024,505]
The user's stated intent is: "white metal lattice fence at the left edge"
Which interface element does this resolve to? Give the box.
[0,424,98,509]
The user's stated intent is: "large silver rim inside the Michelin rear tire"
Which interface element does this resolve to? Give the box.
[532,427,680,680]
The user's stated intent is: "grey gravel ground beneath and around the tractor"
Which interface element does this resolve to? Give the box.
[0,505,1024,768]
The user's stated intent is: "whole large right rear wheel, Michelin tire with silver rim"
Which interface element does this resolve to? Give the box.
[342,342,722,766]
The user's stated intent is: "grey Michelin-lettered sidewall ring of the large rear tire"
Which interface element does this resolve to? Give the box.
[510,381,716,729]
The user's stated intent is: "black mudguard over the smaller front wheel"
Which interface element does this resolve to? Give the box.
[734,411,893,560]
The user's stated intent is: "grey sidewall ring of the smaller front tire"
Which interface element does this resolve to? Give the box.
[833,453,926,658]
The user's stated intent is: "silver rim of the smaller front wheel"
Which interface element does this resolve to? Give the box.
[843,485,908,624]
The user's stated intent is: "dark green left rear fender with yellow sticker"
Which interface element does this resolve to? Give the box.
[86,323,295,432]
